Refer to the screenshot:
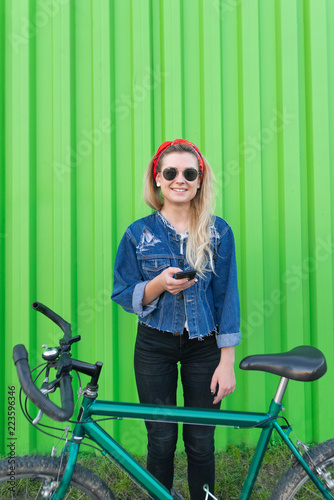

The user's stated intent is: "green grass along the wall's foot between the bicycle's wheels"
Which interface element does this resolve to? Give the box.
[75,442,291,500]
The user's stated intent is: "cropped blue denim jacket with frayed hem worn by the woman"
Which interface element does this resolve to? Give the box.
[111,212,240,347]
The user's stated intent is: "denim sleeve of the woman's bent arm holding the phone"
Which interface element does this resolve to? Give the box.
[111,228,159,318]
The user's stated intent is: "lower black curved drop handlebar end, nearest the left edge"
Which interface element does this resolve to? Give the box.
[13,344,74,422]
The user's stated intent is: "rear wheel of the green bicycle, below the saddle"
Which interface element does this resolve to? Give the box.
[269,439,334,500]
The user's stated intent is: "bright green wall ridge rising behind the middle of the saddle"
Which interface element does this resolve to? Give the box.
[281,2,304,434]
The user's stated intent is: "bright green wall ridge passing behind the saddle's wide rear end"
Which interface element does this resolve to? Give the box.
[309,1,333,439]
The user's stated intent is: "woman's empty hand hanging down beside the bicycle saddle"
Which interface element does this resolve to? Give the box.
[210,347,236,404]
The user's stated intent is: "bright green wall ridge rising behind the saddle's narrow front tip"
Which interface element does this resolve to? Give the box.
[239,0,264,422]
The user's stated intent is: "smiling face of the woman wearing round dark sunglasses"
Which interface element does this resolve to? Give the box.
[156,151,200,206]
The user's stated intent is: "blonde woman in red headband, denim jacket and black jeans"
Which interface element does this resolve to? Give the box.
[112,139,240,500]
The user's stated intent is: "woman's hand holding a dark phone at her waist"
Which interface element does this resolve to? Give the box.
[142,267,197,306]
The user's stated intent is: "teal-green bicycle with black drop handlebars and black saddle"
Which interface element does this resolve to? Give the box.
[0,302,334,500]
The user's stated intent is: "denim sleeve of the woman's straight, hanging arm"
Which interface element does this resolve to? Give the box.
[212,226,241,347]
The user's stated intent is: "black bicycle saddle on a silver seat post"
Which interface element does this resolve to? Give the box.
[239,345,327,382]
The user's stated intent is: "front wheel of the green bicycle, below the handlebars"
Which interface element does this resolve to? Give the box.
[0,455,115,500]
